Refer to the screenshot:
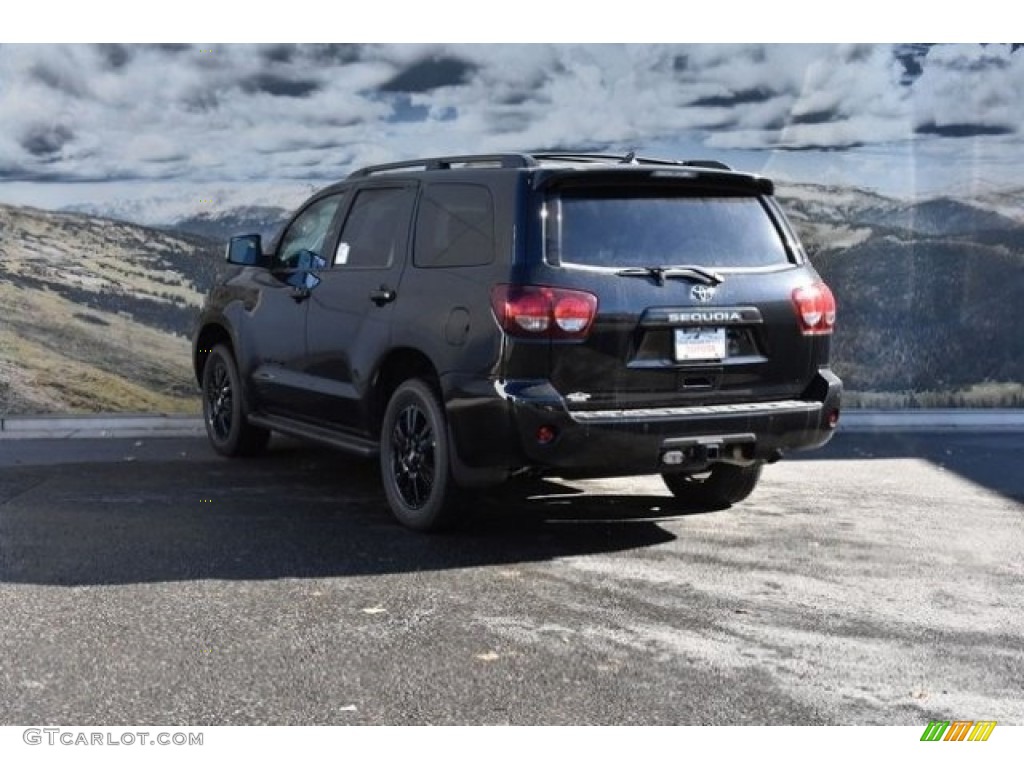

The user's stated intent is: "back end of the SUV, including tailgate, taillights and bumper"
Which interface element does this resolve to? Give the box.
[483,169,842,505]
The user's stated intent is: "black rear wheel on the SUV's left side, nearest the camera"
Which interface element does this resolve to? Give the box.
[380,379,461,531]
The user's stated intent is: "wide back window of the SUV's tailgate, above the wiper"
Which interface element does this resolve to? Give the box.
[547,189,790,267]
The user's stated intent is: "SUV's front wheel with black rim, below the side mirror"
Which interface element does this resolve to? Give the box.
[203,344,270,456]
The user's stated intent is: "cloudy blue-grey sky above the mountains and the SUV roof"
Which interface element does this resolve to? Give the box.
[0,44,1024,215]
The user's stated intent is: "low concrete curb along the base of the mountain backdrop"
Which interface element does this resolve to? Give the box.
[6,409,1024,439]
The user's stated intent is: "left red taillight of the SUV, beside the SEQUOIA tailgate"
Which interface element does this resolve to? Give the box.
[490,285,597,339]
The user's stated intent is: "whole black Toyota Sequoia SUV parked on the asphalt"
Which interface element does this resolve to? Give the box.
[194,153,842,529]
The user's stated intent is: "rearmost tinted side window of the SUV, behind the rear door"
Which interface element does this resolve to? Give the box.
[413,183,495,267]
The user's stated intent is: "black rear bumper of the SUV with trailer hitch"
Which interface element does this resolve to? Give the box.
[454,369,843,477]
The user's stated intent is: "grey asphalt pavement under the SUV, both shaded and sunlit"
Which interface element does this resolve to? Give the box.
[0,432,1024,727]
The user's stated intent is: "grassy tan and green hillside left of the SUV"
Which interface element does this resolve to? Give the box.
[0,206,221,414]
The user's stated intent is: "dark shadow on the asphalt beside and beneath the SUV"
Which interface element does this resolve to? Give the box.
[0,444,685,585]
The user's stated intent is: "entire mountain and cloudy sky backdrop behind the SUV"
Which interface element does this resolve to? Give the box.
[0,44,1024,416]
